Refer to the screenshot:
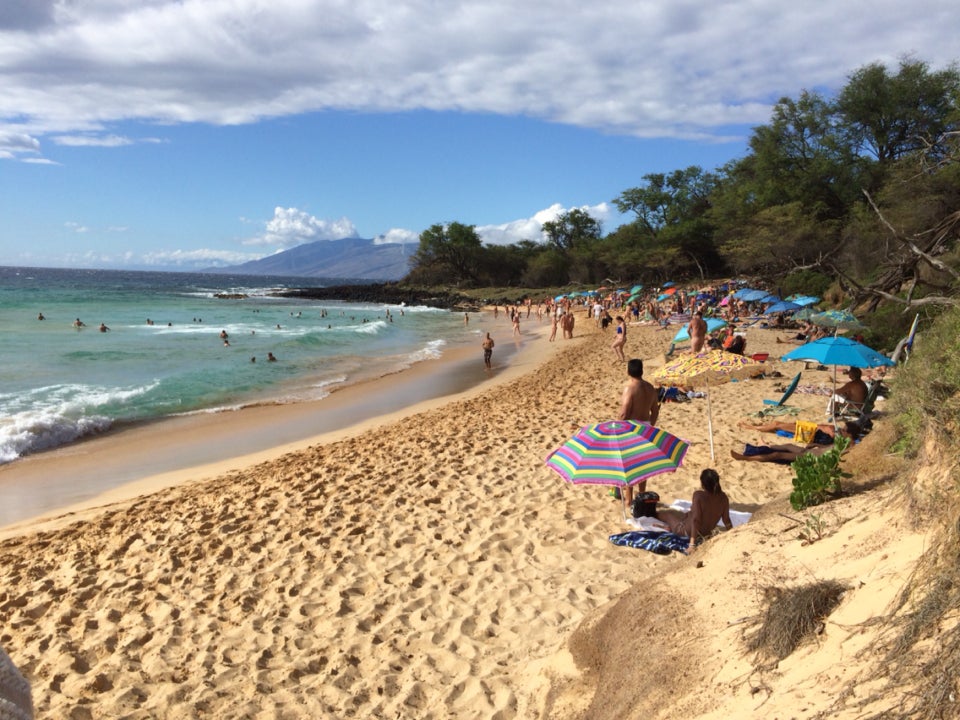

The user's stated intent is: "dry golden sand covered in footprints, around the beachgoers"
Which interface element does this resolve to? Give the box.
[0,313,925,718]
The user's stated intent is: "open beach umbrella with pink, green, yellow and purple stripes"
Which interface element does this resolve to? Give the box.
[546,420,689,487]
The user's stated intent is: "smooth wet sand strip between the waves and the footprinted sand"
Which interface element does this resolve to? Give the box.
[0,310,549,538]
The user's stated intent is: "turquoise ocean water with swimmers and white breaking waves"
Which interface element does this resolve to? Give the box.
[0,267,476,463]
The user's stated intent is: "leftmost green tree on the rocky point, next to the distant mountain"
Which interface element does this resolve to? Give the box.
[410,222,483,285]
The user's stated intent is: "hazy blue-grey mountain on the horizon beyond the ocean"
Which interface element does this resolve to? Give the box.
[205,238,417,281]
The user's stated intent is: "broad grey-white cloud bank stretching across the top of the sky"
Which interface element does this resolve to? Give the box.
[0,0,957,146]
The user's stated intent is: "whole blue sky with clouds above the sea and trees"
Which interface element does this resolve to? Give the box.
[0,0,960,270]
